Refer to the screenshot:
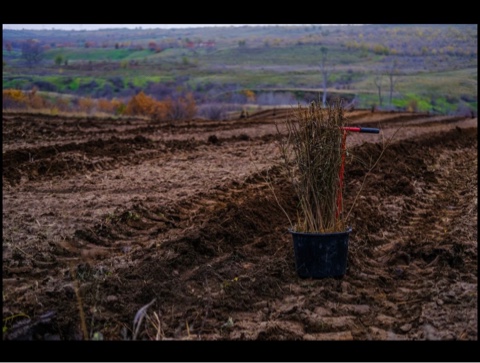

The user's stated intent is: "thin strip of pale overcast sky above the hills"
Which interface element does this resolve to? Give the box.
[2,24,356,30]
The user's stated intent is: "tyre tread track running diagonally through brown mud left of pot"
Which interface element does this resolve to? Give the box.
[54,167,292,257]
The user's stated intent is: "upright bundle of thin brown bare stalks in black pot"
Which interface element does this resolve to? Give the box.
[280,100,346,233]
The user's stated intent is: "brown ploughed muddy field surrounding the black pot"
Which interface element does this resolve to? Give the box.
[2,109,478,350]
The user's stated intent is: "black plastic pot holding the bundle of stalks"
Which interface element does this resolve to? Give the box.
[288,228,352,278]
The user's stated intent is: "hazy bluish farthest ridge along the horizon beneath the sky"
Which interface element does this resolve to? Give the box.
[3,24,477,56]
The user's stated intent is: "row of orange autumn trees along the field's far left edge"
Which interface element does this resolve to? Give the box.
[3,88,197,121]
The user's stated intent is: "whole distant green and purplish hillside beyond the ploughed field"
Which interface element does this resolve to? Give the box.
[3,24,478,113]
